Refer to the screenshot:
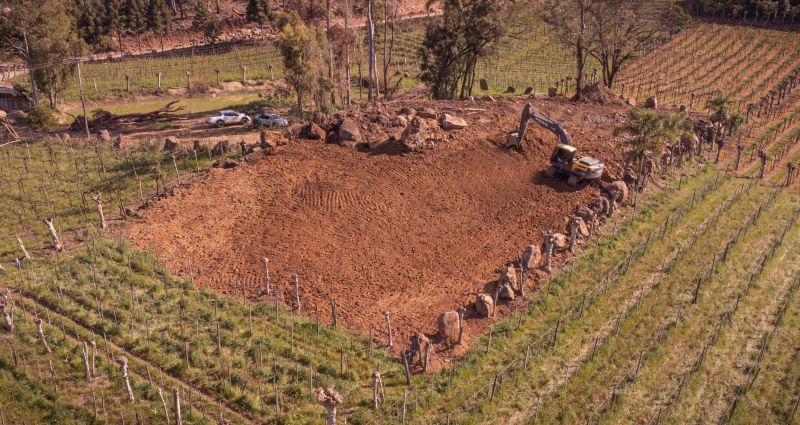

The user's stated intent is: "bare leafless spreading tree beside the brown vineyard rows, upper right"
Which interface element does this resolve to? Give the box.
[587,0,690,88]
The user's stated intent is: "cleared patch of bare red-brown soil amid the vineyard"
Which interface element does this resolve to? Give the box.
[127,100,625,358]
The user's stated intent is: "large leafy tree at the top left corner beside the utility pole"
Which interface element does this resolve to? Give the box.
[0,0,86,108]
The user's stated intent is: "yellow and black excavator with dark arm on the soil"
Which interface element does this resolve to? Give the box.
[506,103,605,186]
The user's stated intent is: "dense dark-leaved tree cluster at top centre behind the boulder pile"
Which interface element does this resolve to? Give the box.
[419,0,504,99]
